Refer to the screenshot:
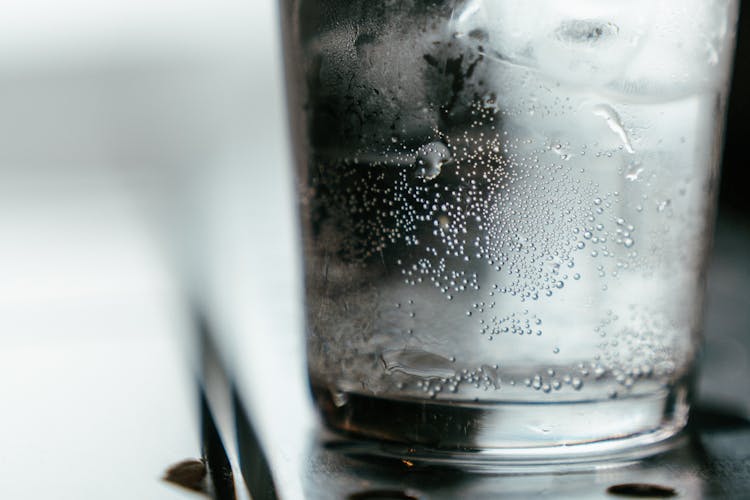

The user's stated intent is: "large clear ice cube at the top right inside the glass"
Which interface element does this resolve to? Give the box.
[452,0,737,100]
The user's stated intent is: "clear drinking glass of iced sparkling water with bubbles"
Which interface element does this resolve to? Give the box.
[282,0,738,468]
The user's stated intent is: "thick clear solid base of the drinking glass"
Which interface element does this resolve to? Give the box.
[313,383,688,473]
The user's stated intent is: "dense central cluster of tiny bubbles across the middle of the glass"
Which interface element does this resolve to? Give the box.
[315,99,612,301]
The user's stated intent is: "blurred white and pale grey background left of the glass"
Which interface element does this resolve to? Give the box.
[0,0,312,499]
